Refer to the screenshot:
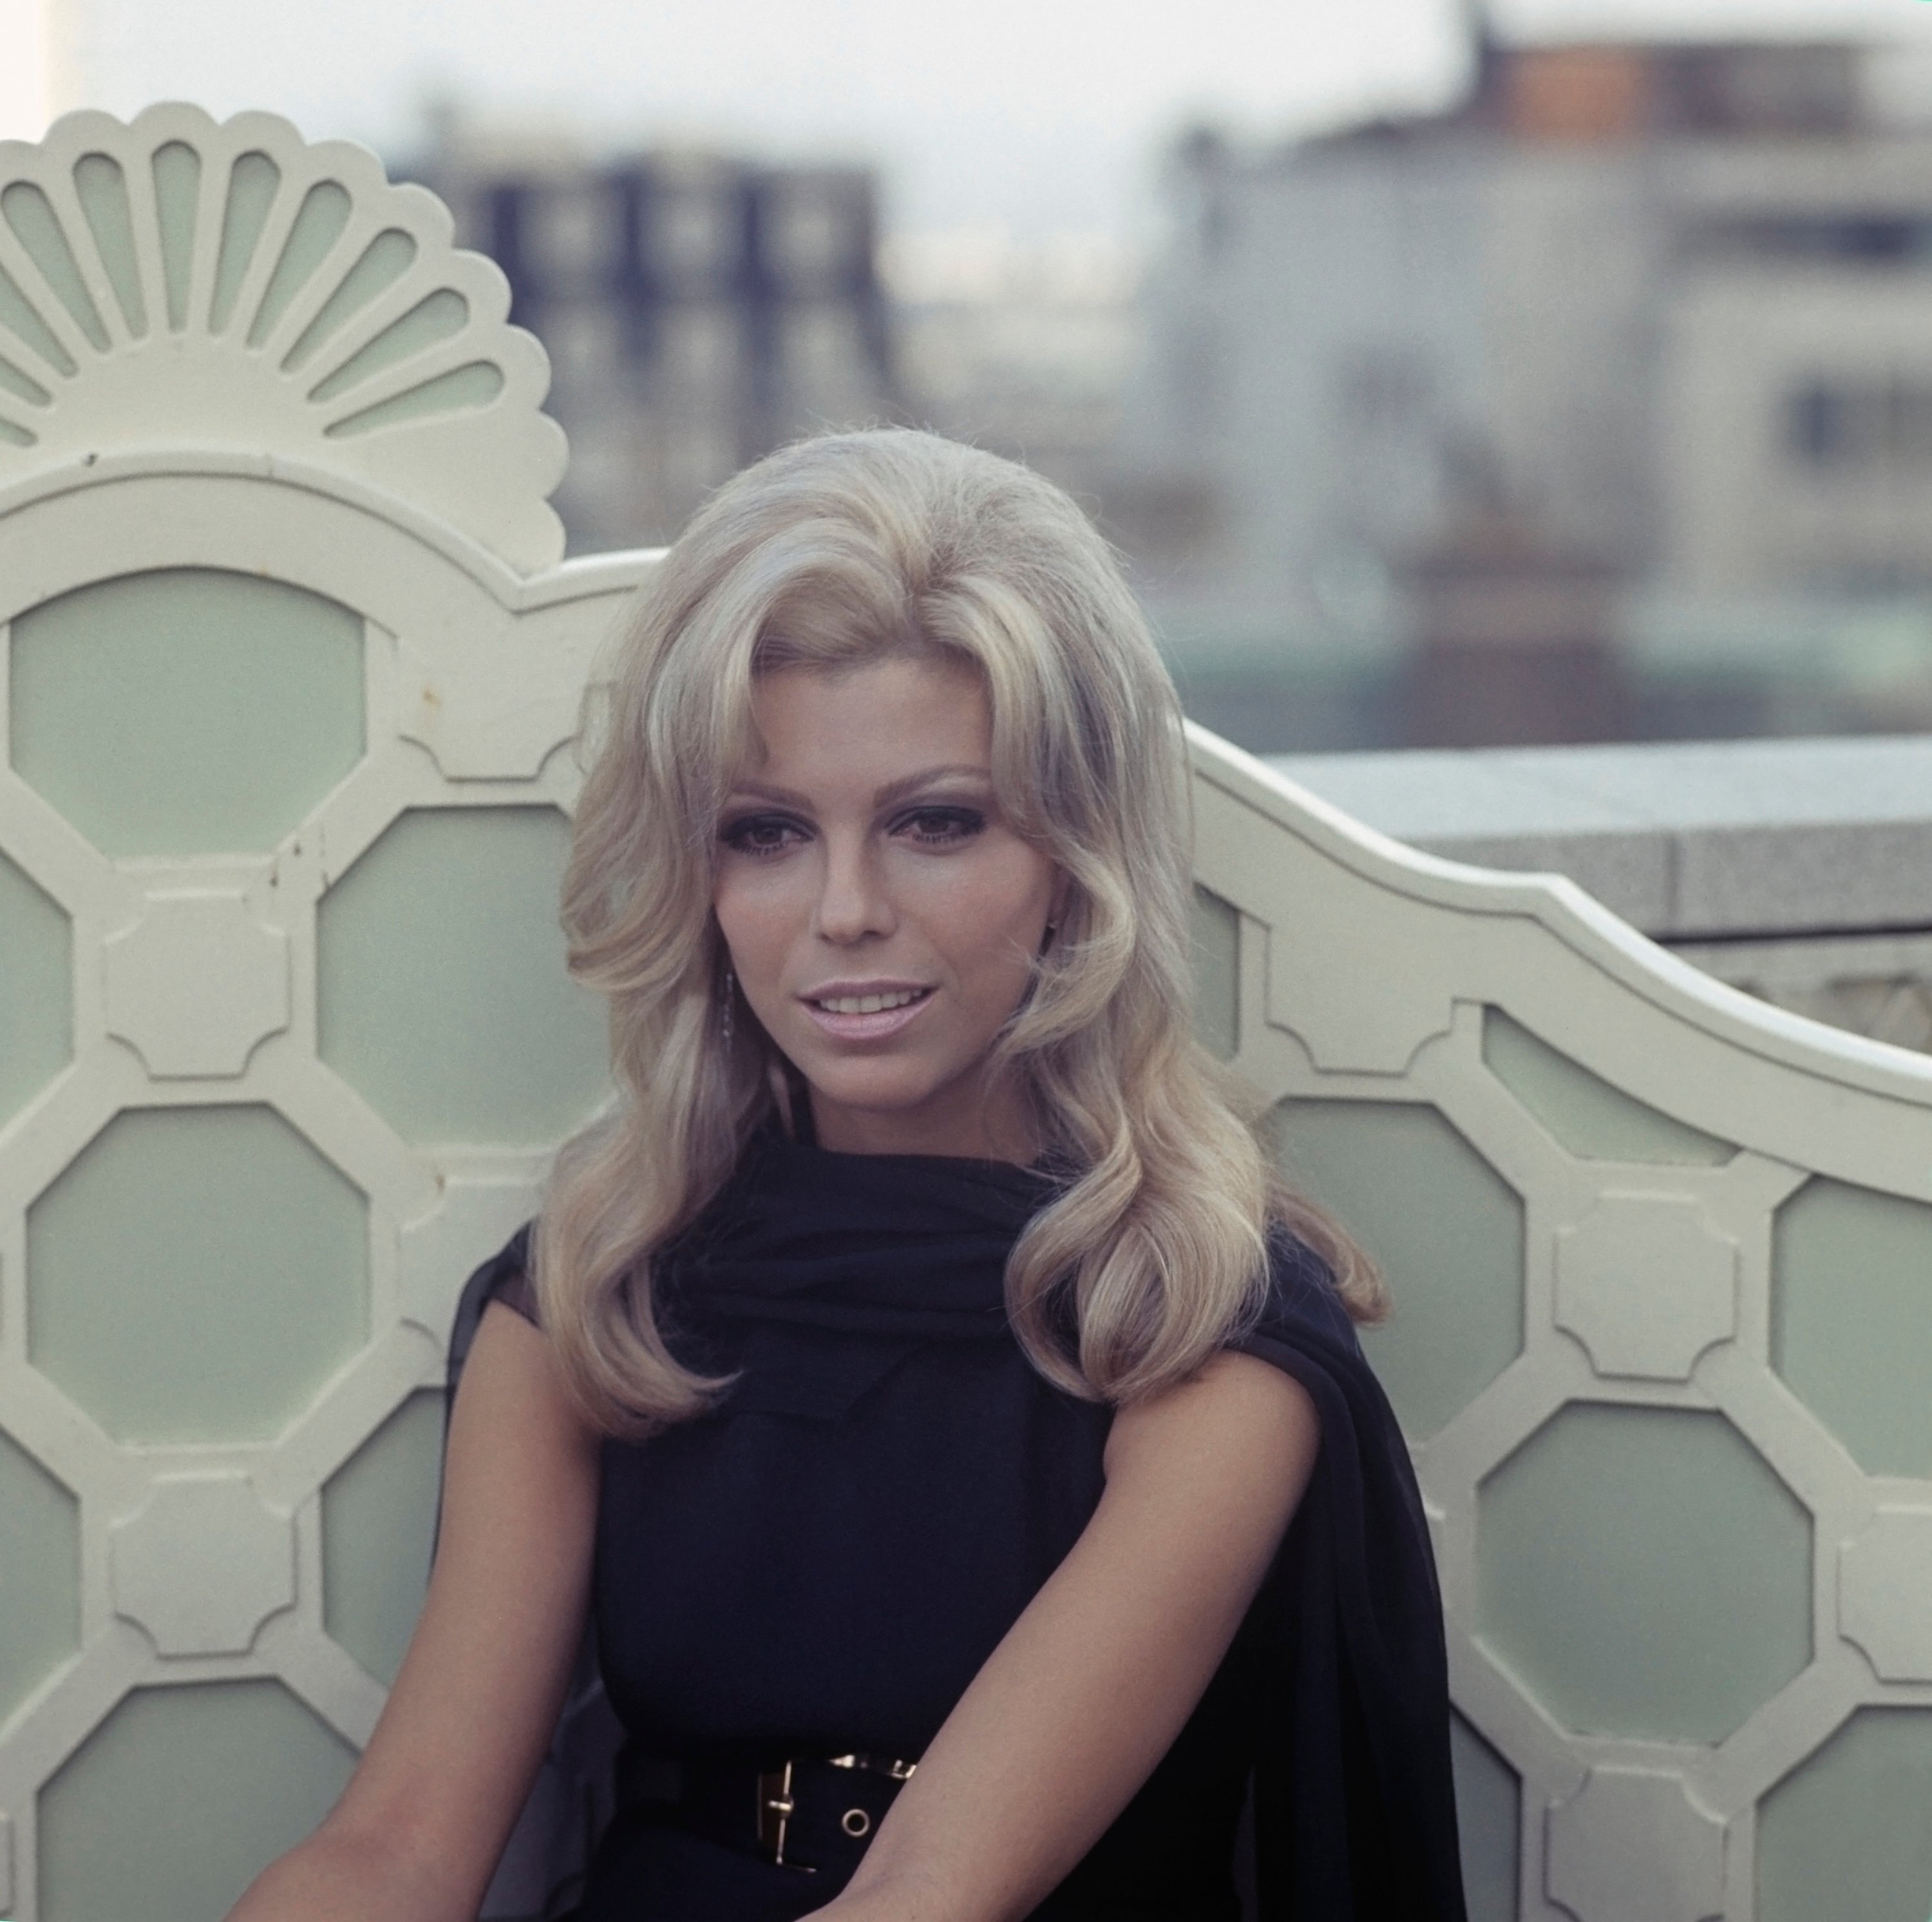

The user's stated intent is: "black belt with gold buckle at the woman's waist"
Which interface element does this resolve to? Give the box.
[618,1754,916,1878]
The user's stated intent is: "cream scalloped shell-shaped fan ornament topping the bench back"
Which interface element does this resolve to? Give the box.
[0,104,564,572]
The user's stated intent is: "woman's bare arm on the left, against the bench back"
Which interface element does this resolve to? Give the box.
[230,1304,597,1922]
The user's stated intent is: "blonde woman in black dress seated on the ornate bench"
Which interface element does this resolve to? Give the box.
[234,431,1463,1922]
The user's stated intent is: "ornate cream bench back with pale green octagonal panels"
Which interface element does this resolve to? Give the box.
[0,106,1932,1922]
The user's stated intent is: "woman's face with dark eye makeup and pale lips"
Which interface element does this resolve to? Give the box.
[713,655,1063,1161]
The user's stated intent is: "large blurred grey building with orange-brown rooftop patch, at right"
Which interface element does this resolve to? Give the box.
[1121,35,1932,746]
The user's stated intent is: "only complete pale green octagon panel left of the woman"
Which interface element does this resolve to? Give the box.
[27,1105,369,1443]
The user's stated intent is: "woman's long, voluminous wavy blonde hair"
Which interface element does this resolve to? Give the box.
[533,429,1381,1435]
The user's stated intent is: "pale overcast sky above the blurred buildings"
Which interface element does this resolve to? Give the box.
[41,0,1932,234]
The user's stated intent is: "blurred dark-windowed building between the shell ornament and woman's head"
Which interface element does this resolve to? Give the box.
[415,118,898,551]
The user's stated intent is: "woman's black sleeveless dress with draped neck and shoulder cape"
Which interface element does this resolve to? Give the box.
[458,1124,1463,1922]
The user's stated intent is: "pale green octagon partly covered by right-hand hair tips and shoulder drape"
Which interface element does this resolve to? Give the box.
[1273,1101,1522,1441]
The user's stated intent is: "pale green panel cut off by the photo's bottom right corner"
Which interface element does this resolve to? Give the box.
[1756,1708,1932,1922]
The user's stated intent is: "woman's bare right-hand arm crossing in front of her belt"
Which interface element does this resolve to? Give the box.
[817,1354,1320,1922]
